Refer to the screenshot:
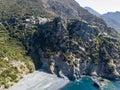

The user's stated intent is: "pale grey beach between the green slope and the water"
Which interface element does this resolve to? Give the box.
[8,70,70,90]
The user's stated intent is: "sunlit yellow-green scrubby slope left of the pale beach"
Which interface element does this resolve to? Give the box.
[0,26,34,88]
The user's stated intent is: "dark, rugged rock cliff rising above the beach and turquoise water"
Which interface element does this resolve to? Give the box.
[31,18,120,80]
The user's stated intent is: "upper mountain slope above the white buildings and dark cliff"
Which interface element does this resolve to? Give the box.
[1,0,117,39]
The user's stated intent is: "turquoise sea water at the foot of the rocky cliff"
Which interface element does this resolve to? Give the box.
[61,77,120,90]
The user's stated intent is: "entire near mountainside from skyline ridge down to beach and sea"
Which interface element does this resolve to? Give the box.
[0,0,120,88]
